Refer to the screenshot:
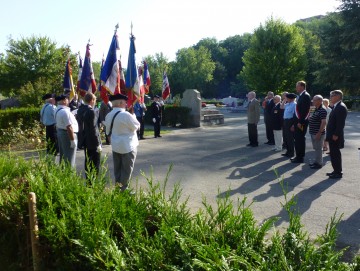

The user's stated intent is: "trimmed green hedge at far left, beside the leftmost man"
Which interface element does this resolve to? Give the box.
[0,107,40,129]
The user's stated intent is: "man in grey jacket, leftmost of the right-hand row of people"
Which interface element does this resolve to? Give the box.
[247,91,260,147]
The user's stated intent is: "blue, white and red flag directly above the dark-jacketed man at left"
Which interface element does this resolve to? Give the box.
[80,43,97,96]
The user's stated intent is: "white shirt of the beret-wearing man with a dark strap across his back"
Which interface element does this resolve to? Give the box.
[105,107,140,154]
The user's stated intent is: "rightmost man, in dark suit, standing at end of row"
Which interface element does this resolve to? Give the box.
[326,90,347,179]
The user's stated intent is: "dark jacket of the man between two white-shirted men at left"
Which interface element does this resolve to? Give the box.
[83,106,101,150]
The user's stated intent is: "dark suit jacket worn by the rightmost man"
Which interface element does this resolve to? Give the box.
[326,102,347,148]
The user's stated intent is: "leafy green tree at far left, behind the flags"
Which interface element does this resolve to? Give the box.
[0,36,76,96]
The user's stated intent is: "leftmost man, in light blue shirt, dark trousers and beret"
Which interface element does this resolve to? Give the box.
[40,93,58,155]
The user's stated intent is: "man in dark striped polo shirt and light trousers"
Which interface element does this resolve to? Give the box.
[309,95,327,169]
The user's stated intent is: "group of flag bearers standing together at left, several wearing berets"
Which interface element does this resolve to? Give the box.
[40,93,162,191]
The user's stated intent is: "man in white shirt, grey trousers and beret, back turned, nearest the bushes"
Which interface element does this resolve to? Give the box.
[105,94,140,191]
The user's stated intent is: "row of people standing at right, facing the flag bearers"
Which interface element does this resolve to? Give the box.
[247,81,347,179]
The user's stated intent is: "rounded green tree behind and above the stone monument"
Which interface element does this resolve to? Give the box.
[169,46,215,97]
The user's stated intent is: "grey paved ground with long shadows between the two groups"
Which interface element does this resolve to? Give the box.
[77,112,360,260]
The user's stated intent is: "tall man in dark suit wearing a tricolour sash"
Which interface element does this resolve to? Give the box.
[291,81,311,163]
